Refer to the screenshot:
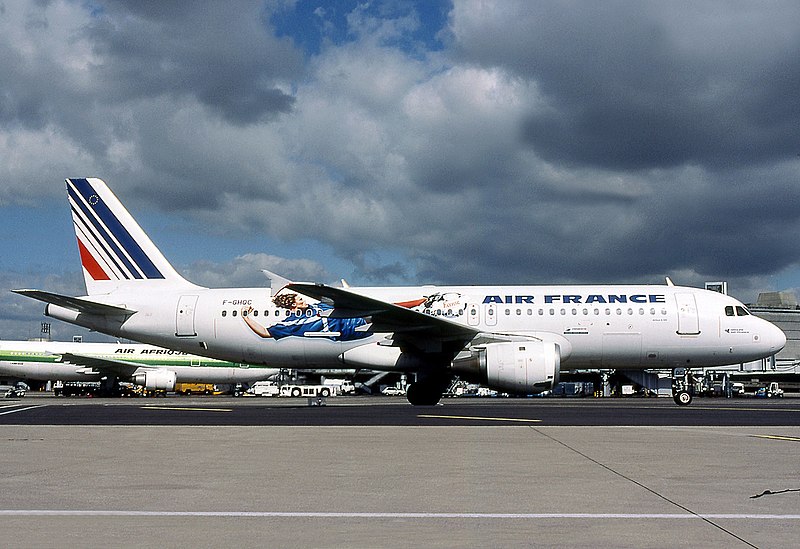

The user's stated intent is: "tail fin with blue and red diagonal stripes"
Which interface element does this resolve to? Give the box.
[66,178,194,295]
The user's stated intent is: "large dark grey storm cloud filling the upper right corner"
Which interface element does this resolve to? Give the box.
[446,2,800,169]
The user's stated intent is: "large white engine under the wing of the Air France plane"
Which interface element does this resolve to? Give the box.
[452,341,561,395]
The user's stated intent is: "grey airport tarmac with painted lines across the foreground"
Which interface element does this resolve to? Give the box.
[0,394,800,547]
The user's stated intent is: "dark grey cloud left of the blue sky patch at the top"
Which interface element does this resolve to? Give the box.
[86,1,301,124]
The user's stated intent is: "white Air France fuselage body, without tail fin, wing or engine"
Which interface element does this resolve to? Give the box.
[42,285,785,370]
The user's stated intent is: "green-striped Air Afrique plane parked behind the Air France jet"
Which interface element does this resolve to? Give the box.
[0,341,280,391]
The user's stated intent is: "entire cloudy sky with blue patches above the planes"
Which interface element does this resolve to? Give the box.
[0,0,800,339]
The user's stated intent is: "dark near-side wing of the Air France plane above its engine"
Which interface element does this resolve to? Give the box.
[286,282,479,344]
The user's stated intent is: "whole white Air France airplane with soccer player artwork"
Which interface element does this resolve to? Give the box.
[14,178,786,405]
